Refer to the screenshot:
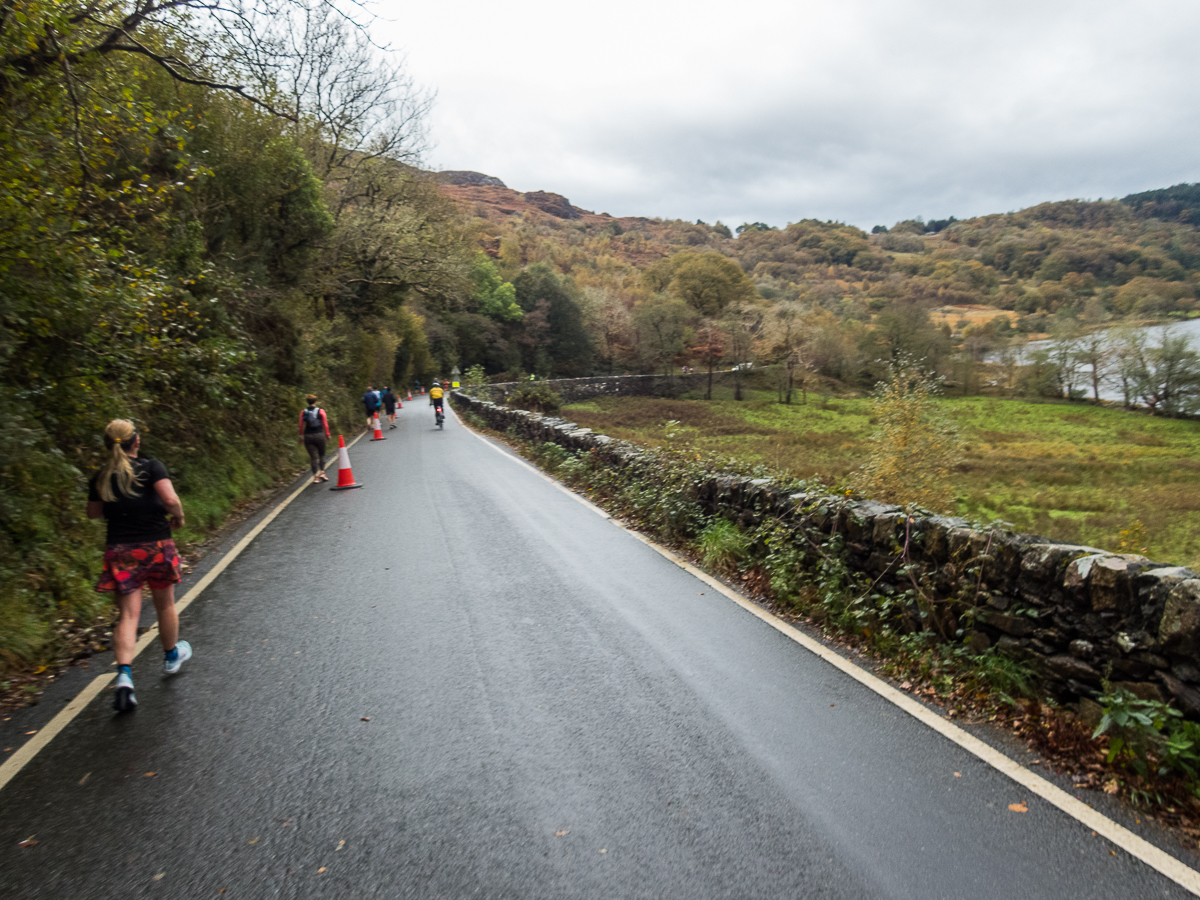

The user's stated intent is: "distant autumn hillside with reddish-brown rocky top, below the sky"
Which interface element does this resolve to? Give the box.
[429,173,1200,394]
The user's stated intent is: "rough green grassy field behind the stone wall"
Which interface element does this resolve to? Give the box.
[563,391,1200,570]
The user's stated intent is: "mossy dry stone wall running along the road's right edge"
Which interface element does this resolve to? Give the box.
[452,388,1200,719]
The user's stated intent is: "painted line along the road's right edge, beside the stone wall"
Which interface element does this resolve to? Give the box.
[468,428,1200,896]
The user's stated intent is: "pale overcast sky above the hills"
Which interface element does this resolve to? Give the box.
[373,0,1200,228]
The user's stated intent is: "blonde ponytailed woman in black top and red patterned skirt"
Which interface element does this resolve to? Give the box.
[88,419,192,713]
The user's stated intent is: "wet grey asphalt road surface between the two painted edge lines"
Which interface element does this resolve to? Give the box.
[0,402,1188,900]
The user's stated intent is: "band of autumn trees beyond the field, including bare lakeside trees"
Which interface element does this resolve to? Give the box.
[431,185,1200,413]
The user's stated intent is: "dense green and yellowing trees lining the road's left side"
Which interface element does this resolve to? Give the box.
[0,0,477,670]
